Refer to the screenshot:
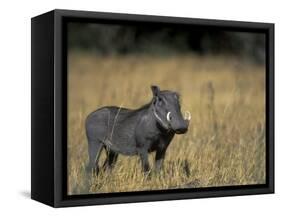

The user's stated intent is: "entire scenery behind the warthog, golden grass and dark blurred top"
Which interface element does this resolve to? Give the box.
[67,23,266,194]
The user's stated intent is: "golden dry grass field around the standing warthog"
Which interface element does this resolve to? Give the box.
[67,53,265,194]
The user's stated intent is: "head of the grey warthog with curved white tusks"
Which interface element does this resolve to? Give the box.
[151,86,191,134]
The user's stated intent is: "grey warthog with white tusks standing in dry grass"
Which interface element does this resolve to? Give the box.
[86,86,191,174]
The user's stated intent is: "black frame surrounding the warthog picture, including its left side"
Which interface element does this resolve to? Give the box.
[31,10,274,207]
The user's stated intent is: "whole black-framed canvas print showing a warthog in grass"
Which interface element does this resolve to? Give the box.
[31,10,274,207]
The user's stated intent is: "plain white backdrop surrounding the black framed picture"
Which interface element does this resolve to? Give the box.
[0,0,281,217]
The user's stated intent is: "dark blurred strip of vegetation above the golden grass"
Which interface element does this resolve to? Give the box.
[68,23,265,64]
